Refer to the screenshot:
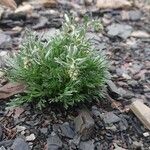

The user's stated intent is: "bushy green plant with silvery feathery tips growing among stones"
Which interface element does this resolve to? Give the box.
[7,16,108,109]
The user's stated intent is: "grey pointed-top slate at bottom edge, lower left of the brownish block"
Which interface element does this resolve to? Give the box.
[47,132,62,150]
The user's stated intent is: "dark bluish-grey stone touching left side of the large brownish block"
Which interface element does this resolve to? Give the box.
[60,122,75,139]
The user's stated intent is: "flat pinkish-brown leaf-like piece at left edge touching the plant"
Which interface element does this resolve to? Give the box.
[0,83,26,99]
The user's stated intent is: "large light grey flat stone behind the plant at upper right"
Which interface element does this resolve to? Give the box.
[107,23,133,39]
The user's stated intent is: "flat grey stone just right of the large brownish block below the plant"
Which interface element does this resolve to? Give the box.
[101,112,121,124]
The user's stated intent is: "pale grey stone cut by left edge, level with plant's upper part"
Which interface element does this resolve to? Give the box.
[0,32,12,49]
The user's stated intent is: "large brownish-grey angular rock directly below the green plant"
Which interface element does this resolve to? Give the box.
[74,109,95,140]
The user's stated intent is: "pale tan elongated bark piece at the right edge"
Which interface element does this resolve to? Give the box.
[130,101,150,130]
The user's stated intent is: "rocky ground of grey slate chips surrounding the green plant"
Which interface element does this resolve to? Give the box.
[0,0,150,150]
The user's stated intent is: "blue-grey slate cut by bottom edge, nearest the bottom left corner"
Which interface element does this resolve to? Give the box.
[11,138,30,150]
